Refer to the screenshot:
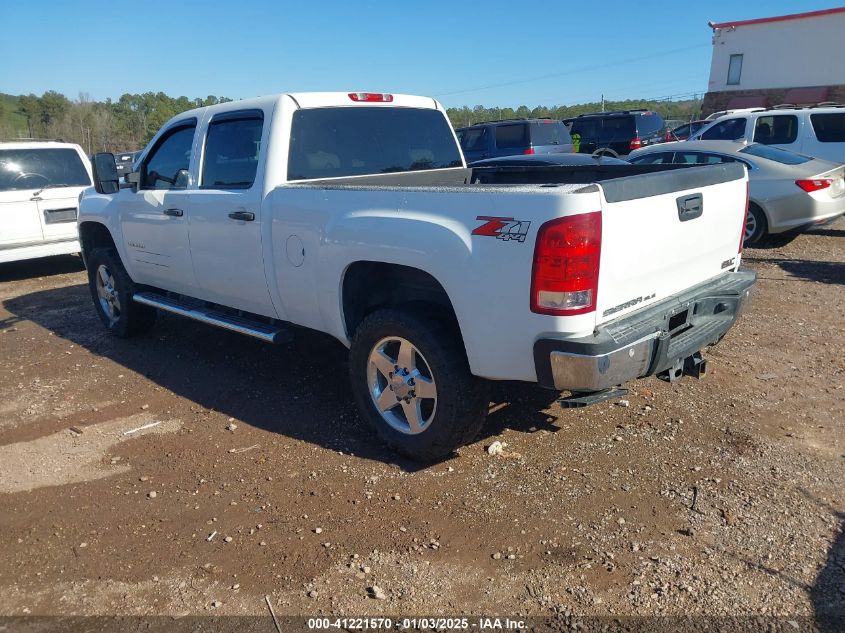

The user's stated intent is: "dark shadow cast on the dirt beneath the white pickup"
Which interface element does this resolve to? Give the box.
[0,284,559,471]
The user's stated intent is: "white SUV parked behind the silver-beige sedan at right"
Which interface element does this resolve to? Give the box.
[689,106,845,163]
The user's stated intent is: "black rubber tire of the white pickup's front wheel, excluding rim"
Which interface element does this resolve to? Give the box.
[87,248,157,338]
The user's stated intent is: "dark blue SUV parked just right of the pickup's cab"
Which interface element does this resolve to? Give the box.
[457,119,573,163]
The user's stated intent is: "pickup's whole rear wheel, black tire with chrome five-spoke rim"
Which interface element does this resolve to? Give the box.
[349,309,489,461]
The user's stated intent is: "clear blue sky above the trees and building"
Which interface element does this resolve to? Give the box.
[0,0,836,107]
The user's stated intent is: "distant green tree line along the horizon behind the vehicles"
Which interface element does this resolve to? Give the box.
[0,90,701,154]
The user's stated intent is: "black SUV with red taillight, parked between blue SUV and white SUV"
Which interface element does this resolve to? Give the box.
[569,110,667,157]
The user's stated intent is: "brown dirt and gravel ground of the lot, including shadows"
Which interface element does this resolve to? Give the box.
[0,220,845,617]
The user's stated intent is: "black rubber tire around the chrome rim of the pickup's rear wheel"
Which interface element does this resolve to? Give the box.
[349,308,490,462]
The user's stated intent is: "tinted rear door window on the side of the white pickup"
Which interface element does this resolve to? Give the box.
[200,110,264,189]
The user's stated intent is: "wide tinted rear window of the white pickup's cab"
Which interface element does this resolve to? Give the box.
[288,107,462,180]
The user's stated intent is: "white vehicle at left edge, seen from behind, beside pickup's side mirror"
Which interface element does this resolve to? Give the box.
[0,141,91,262]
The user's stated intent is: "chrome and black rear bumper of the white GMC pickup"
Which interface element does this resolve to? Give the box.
[534,269,757,392]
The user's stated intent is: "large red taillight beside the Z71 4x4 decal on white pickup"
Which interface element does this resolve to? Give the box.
[531,211,601,316]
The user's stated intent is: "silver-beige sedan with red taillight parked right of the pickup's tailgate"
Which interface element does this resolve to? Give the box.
[628,141,845,246]
